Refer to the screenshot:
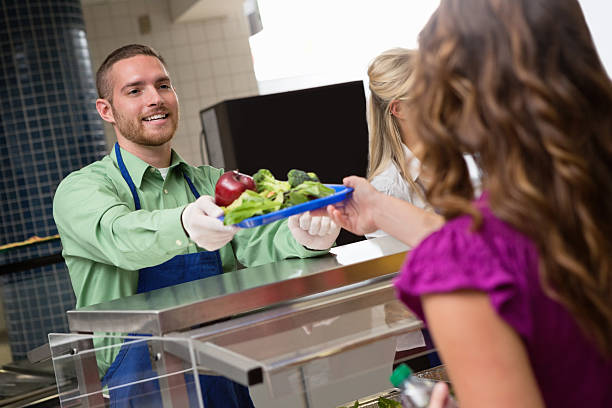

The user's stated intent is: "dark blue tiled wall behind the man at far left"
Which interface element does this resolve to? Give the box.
[0,0,107,360]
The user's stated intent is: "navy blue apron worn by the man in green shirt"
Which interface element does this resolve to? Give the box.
[102,143,254,408]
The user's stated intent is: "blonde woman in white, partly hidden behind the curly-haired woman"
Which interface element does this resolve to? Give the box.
[366,48,480,365]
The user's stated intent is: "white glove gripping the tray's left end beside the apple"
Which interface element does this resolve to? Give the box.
[181,196,239,251]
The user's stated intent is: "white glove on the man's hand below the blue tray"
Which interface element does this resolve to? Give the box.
[289,211,340,250]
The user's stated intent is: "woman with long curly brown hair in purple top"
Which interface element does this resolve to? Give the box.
[328,0,612,407]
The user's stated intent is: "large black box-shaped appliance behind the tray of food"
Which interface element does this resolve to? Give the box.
[200,81,368,245]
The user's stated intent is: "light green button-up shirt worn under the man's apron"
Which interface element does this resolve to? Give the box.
[53,149,325,373]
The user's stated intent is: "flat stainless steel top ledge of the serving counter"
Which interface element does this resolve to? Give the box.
[68,247,405,335]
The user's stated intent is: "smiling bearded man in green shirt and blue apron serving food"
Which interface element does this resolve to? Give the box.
[53,45,340,408]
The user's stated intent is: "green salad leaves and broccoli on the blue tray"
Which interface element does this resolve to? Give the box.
[222,169,334,225]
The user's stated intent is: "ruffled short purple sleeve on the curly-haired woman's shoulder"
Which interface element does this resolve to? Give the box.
[394,217,531,337]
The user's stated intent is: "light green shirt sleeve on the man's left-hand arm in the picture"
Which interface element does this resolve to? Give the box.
[53,173,189,270]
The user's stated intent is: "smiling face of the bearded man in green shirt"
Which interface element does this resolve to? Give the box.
[109,55,179,146]
